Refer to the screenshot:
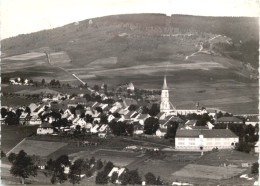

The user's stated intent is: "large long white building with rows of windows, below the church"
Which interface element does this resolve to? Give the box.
[175,129,239,151]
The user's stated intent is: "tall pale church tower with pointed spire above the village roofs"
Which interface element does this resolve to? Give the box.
[160,76,172,113]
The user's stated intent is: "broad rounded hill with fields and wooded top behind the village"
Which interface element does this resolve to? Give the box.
[2,14,259,112]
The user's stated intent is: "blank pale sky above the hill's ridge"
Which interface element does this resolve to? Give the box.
[0,0,259,39]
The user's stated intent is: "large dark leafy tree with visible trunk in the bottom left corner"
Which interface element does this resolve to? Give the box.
[10,150,38,184]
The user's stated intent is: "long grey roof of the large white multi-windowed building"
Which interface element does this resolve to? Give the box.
[176,129,238,138]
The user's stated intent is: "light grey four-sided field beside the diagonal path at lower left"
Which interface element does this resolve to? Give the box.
[9,139,67,157]
